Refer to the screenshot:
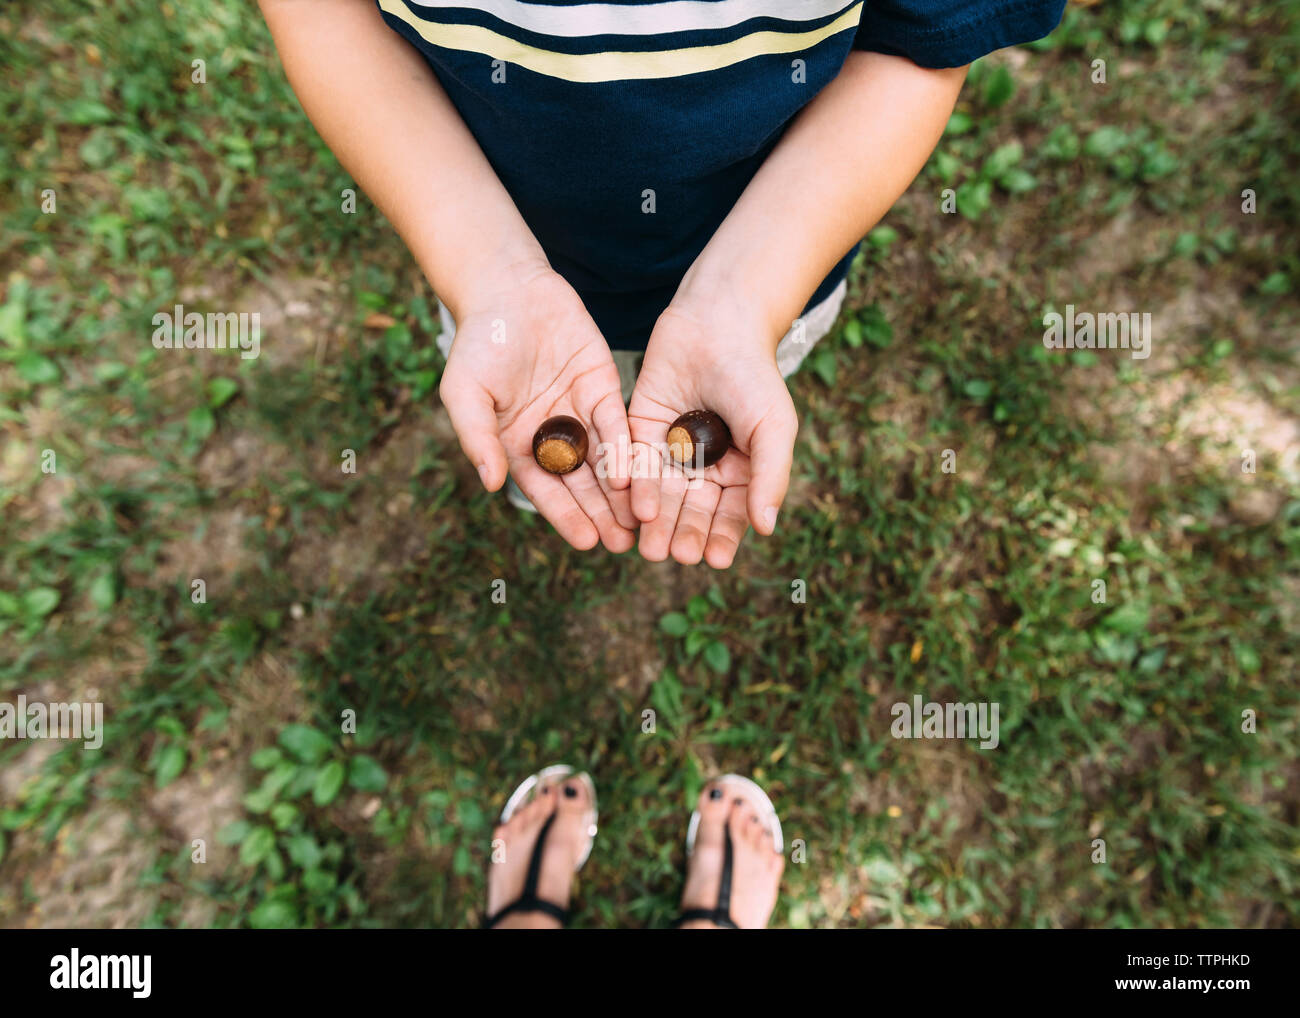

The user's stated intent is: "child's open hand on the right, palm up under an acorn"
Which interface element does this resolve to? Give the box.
[628,300,798,569]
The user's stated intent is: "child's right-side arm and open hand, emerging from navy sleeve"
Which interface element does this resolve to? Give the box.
[628,52,966,568]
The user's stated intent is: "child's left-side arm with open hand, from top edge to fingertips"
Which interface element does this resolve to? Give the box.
[260,0,636,551]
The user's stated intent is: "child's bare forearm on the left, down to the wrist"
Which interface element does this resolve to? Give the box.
[260,0,547,320]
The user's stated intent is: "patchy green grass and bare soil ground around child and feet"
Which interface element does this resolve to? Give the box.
[0,0,1300,927]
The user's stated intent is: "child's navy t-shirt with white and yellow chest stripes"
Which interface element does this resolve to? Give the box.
[377,0,1065,350]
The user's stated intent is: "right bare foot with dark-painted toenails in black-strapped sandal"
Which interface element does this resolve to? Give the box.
[681,781,785,930]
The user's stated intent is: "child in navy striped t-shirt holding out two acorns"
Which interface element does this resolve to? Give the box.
[261,0,1065,568]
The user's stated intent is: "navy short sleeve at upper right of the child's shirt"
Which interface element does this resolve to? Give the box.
[853,0,1065,68]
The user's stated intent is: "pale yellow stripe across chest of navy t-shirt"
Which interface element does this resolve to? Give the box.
[378,0,862,83]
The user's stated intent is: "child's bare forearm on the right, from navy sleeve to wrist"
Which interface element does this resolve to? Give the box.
[673,52,966,347]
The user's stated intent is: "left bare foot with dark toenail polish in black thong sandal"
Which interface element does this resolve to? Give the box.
[488,776,592,930]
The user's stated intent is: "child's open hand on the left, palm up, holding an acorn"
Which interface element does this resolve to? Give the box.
[438,268,637,551]
